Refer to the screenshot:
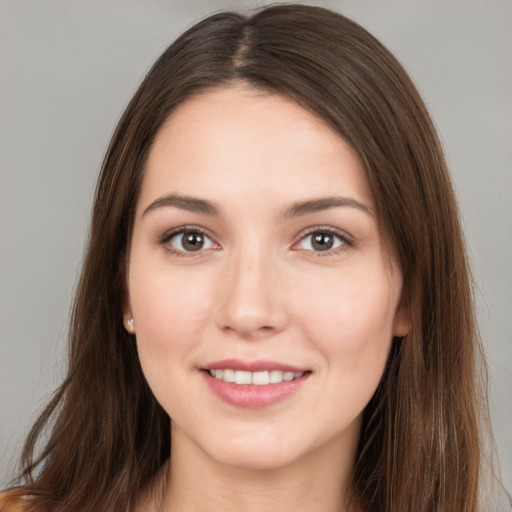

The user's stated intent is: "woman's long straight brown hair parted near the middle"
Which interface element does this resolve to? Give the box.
[3,5,492,512]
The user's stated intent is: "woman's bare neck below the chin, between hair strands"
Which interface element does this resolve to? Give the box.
[156,422,359,512]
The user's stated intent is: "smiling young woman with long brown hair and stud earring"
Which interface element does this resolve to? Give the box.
[3,5,504,512]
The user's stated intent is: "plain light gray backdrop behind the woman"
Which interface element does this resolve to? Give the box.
[0,0,512,488]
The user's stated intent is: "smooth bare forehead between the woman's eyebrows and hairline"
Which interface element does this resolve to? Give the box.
[140,87,372,215]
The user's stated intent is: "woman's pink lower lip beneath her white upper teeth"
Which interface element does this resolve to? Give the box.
[202,372,309,409]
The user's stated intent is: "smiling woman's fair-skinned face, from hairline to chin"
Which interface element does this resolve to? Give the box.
[125,87,407,468]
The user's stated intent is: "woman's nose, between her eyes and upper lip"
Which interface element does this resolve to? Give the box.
[216,251,288,339]
